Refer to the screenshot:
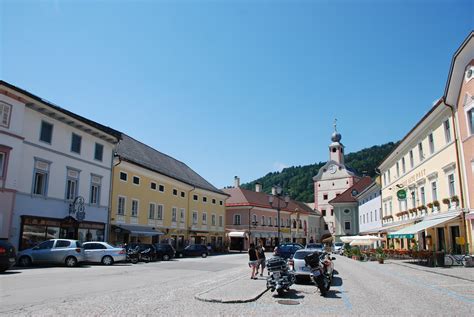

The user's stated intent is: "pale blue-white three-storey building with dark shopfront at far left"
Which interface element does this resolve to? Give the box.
[0,81,117,249]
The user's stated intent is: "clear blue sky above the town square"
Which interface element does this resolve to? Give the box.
[0,0,474,187]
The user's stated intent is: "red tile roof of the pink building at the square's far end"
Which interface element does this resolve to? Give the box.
[222,187,313,213]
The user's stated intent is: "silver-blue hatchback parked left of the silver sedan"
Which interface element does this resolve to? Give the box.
[18,239,85,267]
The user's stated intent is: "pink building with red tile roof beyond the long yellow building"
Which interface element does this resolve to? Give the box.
[223,177,319,250]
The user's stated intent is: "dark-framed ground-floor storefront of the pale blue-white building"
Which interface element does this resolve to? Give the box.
[19,215,105,250]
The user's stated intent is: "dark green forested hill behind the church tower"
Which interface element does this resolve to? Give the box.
[241,142,397,202]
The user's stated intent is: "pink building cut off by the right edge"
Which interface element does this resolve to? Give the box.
[444,32,474,253]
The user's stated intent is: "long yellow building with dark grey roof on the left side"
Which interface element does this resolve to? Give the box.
[110,134,228,249]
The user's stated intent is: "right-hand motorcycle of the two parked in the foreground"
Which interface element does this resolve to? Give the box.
[304,252,335,296]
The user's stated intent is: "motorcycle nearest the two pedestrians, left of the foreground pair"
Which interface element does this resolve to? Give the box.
[266,257,296,296]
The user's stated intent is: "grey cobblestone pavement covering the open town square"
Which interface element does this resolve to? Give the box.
[0,254,474,316]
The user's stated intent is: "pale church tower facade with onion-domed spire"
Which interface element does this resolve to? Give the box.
[313,126,360,240]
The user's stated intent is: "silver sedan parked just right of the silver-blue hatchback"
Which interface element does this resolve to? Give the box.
[82,241,127,265]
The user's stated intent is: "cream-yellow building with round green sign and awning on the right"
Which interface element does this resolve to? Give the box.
[379,100,465,253]
